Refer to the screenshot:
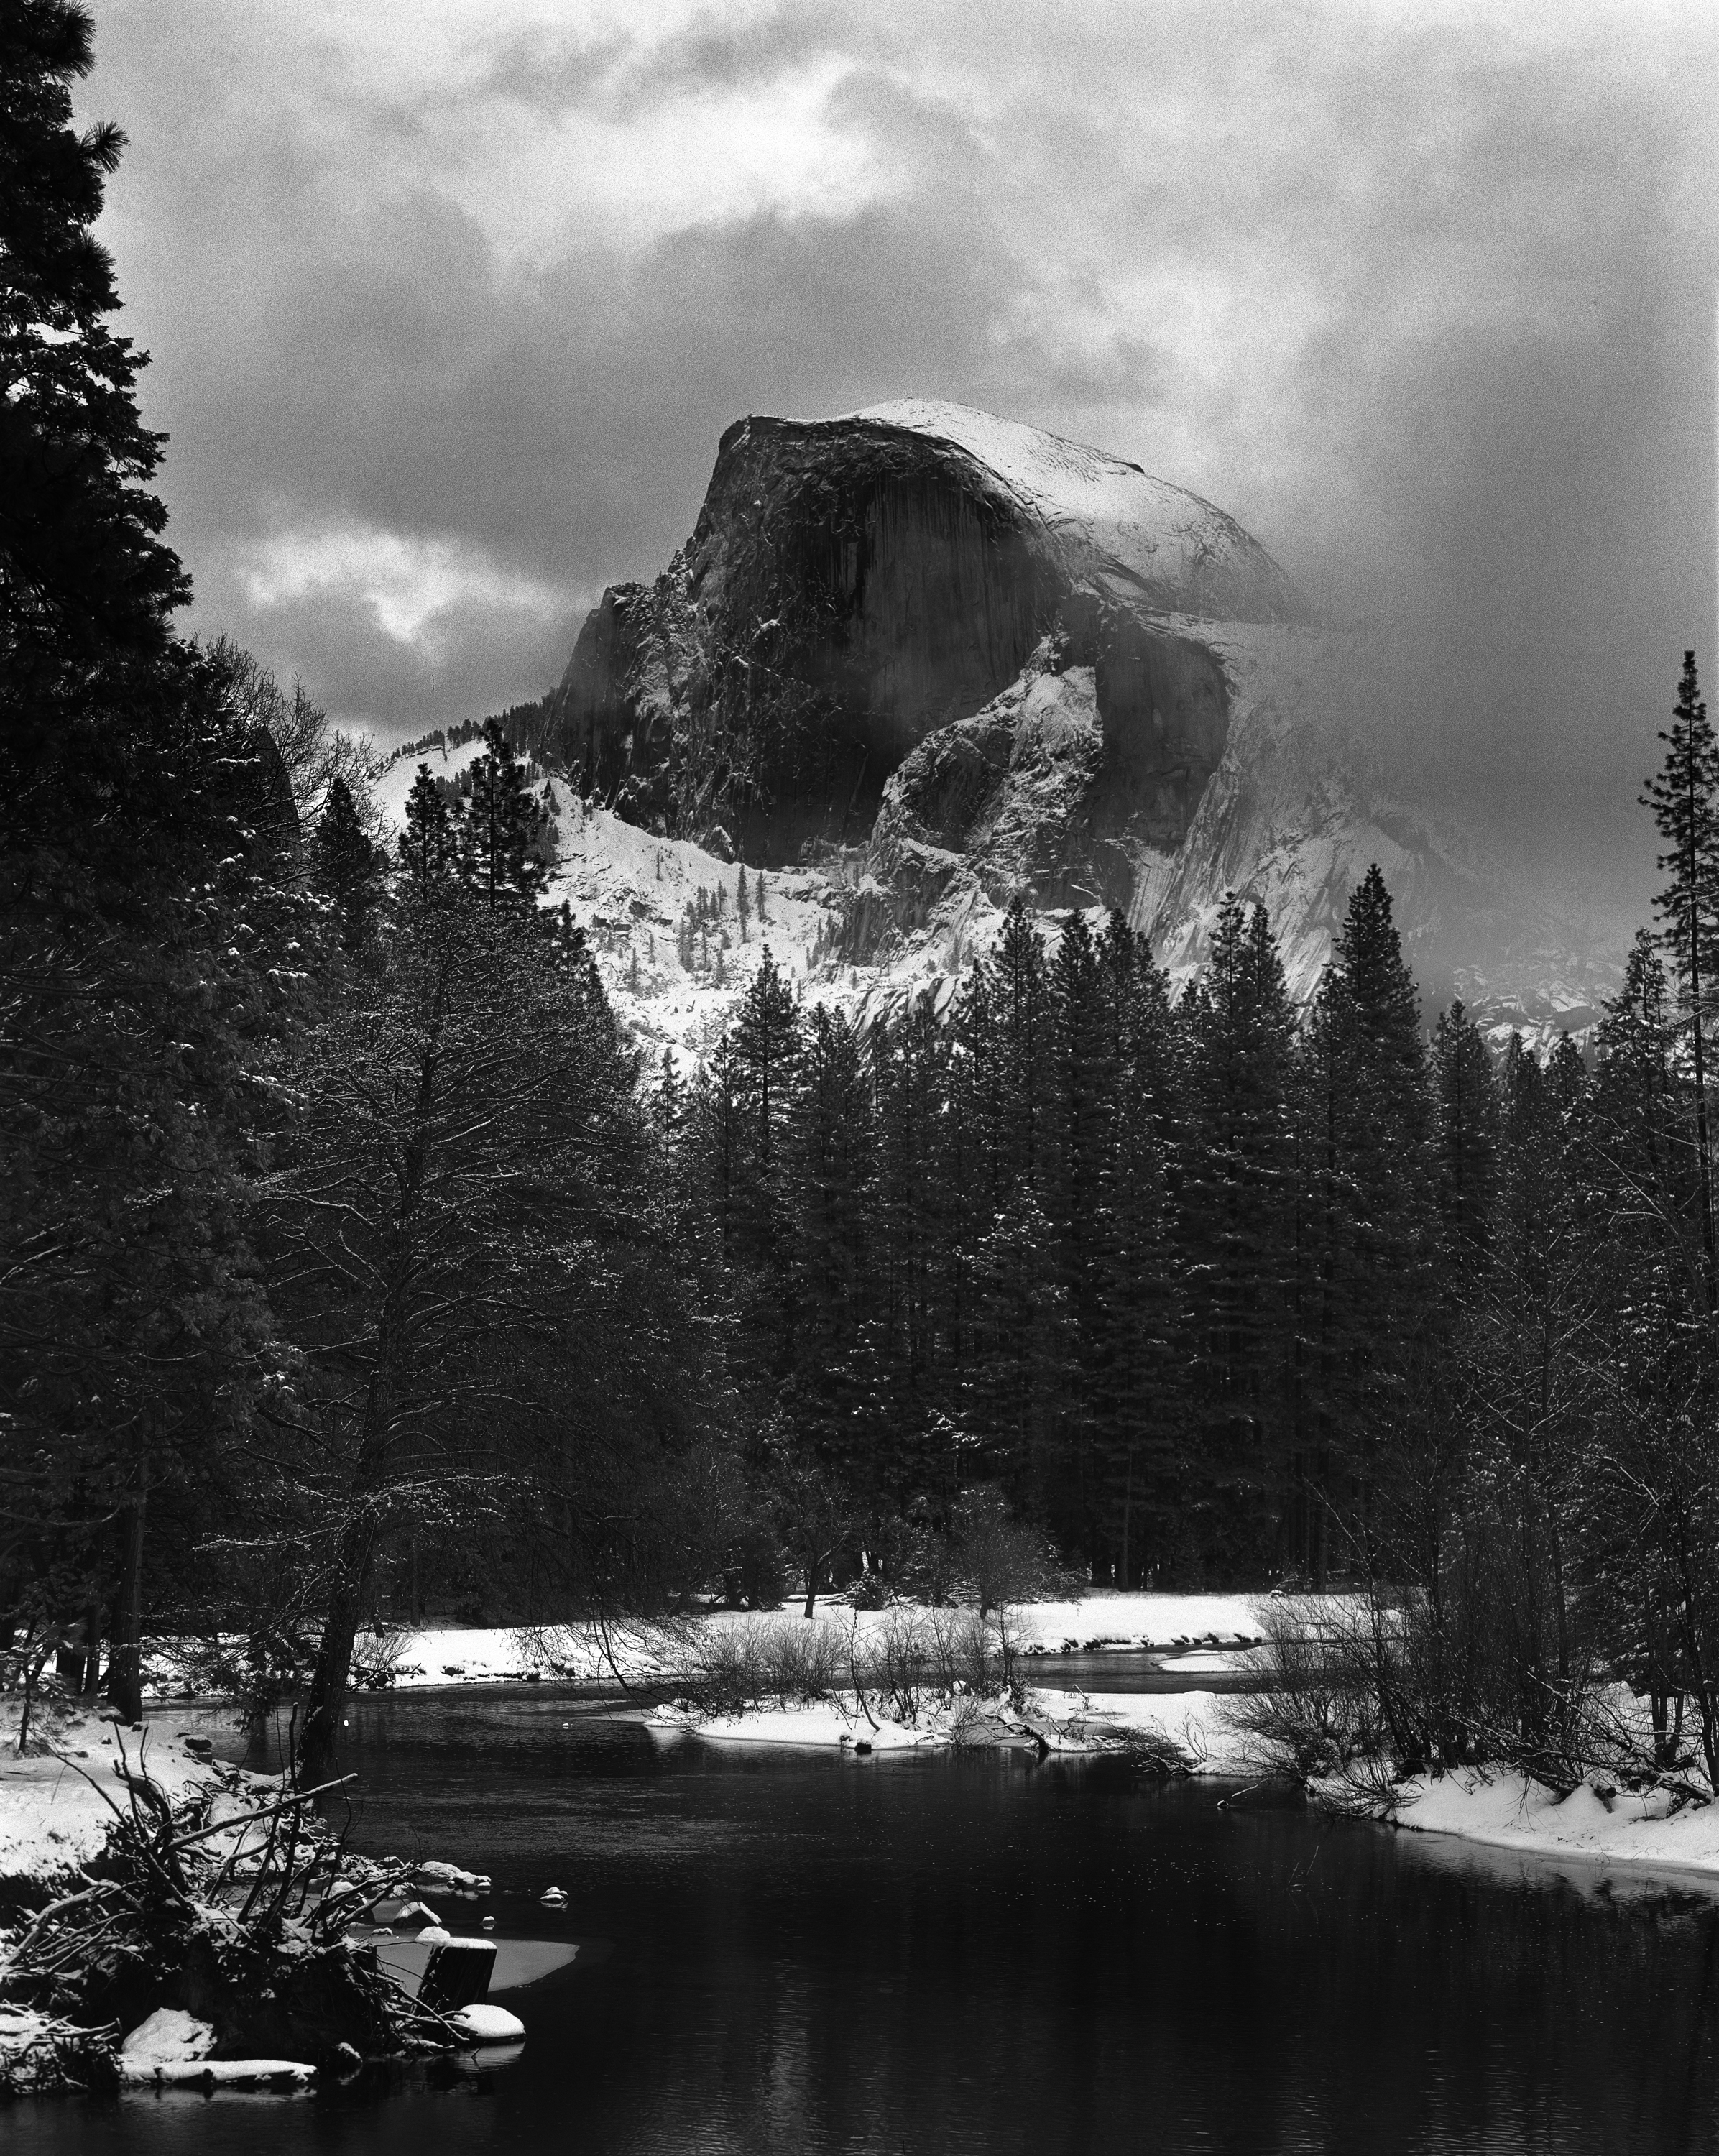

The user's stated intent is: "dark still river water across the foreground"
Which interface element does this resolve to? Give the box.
[0,1695,1719,2156]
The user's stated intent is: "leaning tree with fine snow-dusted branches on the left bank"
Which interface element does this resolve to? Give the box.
[265,886,647,1772]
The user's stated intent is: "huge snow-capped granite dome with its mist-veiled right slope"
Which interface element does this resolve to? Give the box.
[548,401,1622,1041]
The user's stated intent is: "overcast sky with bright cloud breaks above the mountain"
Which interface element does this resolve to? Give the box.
[80,0,1719,914]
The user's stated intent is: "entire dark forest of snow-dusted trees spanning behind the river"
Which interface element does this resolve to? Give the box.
[0,0,1719,1779]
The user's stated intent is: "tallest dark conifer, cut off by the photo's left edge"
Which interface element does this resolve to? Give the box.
[0,0,315,1714]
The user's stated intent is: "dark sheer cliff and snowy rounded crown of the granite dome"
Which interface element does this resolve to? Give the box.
[556,405,1301,862]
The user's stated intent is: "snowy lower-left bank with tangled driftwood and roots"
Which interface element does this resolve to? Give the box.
[0,1699,522,2098]
